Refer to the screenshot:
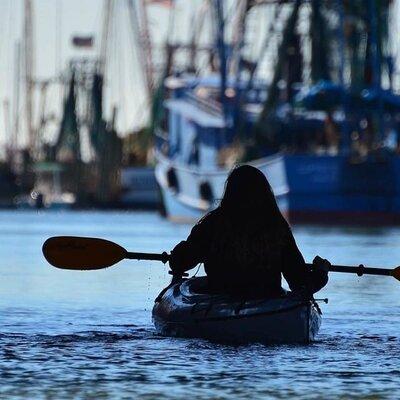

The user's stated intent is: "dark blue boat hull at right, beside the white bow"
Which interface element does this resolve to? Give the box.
[284,155,400,224]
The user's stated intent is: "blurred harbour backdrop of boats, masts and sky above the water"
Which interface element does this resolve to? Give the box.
[0,0,400,225]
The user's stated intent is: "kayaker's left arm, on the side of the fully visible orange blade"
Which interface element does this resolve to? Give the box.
[169,223,205,275]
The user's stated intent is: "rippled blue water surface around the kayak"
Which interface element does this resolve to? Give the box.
[0,212,400,399]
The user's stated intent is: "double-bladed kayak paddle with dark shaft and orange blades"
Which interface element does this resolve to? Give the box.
[42,236,400,281]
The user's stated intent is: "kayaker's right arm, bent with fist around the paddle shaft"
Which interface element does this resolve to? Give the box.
[282,232,328,294]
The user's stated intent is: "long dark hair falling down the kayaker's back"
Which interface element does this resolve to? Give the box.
[211,165,289,267]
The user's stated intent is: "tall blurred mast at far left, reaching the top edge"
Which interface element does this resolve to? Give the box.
[24,0,35,151]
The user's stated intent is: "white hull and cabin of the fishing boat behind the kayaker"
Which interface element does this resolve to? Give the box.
[155,76,288,222]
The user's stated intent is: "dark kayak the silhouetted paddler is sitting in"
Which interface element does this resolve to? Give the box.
[153,277,321,343]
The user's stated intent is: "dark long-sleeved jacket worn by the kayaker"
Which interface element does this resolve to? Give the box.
[170,209,328,296]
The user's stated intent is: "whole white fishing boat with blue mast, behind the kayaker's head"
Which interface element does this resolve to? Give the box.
[153,2,288,222]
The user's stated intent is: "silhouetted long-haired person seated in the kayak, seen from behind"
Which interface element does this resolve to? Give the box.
[169,165,329,296]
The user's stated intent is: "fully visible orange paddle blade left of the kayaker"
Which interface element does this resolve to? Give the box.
[42,236,127,270]
